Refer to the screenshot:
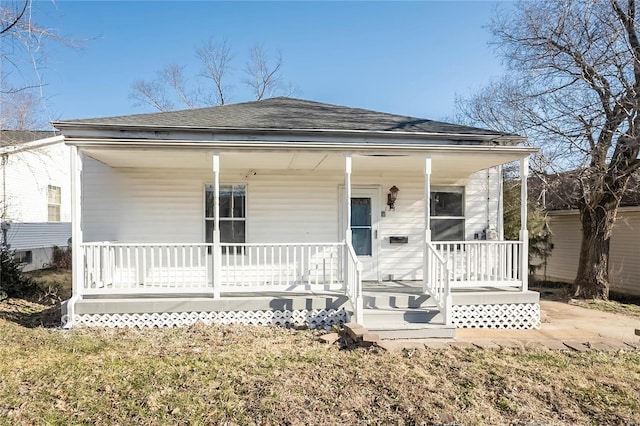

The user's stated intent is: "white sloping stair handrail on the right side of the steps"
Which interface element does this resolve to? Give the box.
[424,242,451,325]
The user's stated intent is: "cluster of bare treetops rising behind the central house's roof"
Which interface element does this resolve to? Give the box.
[129,39,298,111]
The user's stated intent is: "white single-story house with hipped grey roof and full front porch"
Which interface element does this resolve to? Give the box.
[54,98,539,336]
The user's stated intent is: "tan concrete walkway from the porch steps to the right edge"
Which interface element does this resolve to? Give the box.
[378,300,640,352]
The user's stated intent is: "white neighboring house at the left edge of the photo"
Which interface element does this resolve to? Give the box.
[0,130,71,271]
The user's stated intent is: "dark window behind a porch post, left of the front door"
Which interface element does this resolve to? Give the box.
[204,185,247,248]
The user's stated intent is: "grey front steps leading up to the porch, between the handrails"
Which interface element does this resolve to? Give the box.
[363,307,455,339]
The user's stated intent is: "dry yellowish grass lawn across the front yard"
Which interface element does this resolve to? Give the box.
[0,300,640,425]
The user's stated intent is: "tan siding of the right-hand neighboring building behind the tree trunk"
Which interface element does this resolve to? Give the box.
[539,208,640,295]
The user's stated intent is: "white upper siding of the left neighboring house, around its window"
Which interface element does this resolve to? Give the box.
[0,142,71,222]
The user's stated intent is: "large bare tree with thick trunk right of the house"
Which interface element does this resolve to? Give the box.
[458,0,640,299]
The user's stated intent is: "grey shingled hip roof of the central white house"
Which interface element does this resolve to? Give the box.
[54,97,514,137]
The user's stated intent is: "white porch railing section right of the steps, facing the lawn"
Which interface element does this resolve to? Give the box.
[431,241,527,288]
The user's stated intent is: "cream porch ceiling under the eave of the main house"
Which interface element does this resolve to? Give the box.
[83,148,523,179]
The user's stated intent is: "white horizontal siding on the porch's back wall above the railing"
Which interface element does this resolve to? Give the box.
[83,158,499,279]
